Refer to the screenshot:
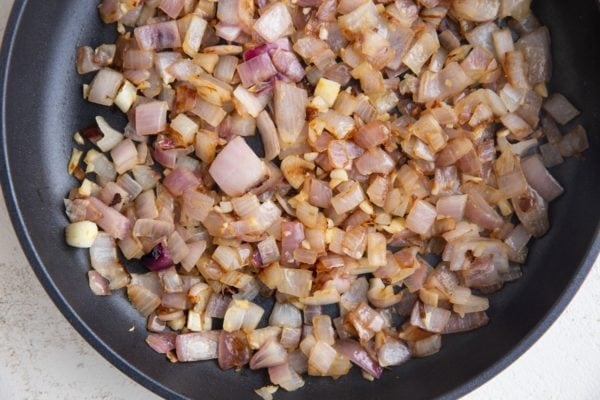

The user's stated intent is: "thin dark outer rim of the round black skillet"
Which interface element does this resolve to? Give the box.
[0,0,600,399]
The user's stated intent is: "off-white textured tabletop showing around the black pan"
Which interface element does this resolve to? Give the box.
[0,0,600,400]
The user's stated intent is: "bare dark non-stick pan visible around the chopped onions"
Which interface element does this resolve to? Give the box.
[0,0,600,400]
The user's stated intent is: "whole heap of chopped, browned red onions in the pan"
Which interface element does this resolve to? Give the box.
[65,0,589,398]
